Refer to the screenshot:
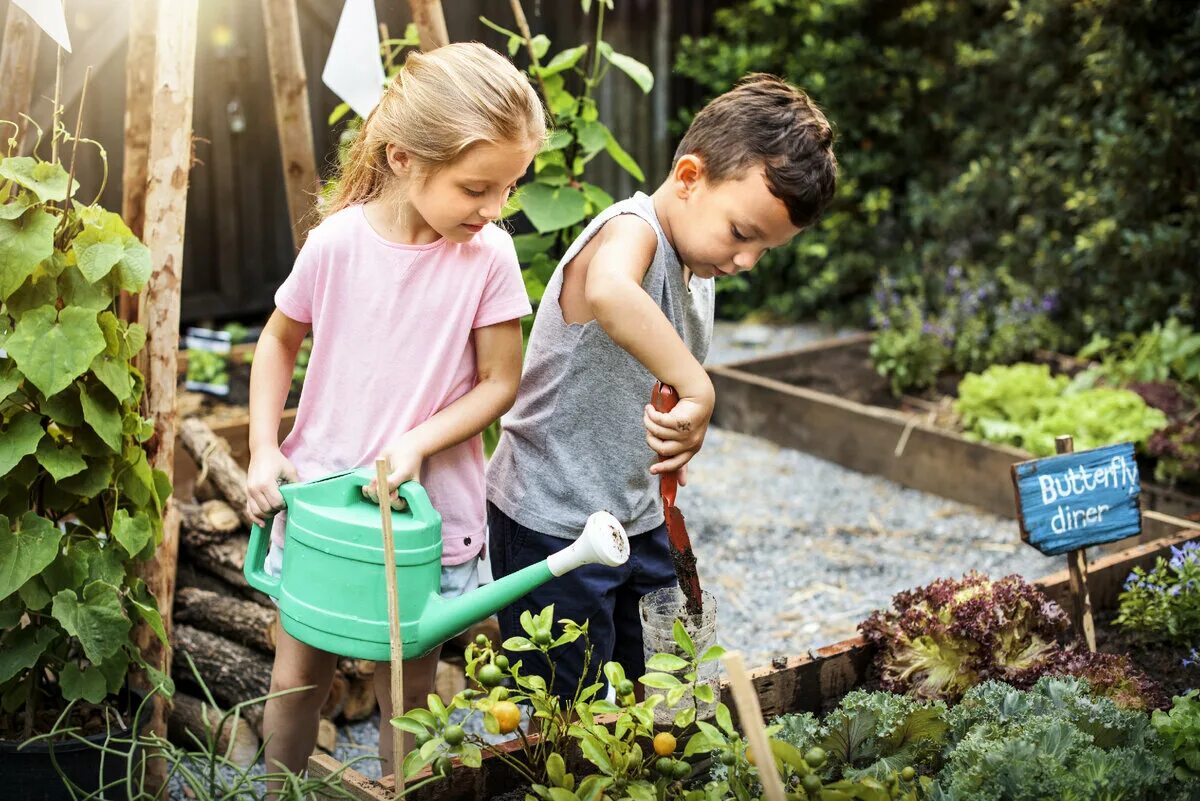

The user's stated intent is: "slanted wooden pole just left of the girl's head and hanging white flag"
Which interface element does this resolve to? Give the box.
[263,0,319,251]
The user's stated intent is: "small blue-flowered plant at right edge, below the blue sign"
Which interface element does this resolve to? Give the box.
[1116,541,1200,646]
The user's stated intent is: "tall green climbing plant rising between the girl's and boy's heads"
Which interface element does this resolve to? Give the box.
[480,0,654,306]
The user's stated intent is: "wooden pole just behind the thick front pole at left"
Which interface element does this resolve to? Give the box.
[118,0,158,321]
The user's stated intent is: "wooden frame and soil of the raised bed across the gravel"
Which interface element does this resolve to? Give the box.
[708,335,1200,536]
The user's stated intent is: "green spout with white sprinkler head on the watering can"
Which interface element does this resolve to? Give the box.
[424,512,629,658]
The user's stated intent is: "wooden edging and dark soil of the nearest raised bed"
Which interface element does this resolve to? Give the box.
[308,531,1200,801]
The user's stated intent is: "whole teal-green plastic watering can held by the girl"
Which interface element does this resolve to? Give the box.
[245,468,629,662]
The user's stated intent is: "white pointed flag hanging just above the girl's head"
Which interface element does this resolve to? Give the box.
[320,0,385,120]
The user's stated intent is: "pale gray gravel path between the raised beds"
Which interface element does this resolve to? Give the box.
[171,323,1062,791]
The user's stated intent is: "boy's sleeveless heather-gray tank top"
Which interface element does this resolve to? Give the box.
[487,192,714,540]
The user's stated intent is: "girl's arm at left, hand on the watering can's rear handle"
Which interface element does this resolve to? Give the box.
[246,309,311,524]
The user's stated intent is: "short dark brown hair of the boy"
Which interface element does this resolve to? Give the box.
[674,73,838,228]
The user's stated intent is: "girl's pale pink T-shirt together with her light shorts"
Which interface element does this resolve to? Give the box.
[272,205,530,565]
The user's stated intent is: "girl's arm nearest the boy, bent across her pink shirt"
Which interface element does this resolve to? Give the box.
[367,320,521,495]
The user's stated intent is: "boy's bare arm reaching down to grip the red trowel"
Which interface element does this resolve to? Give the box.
[584,215,715,474]
